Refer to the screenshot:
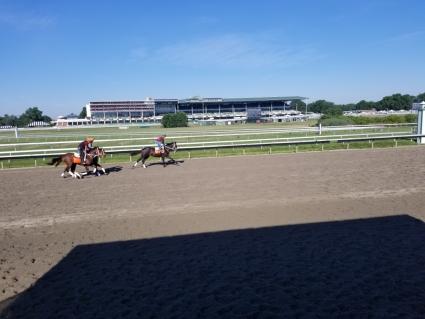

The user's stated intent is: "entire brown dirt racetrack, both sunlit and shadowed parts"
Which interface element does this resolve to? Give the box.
[0,147,425,318]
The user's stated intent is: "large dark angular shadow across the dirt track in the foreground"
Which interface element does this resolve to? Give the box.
[0,215,425,318]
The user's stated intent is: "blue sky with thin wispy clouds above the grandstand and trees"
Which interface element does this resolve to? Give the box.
[0,0,425,117]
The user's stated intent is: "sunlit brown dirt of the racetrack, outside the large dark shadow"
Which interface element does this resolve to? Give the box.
[0,147,425,318]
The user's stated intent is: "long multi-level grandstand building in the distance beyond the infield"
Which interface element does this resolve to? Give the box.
[86,96,305,124]
